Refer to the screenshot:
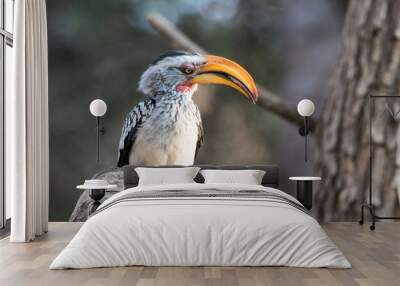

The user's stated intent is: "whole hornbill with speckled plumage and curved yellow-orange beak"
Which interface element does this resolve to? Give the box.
[118,51,257,167]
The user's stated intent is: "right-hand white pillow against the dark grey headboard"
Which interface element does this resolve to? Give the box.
[200,169,265,185]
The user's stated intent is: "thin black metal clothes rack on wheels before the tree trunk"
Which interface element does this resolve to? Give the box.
[359,95,400,230]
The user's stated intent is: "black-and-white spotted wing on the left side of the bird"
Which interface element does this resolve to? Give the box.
[118,98,155,167]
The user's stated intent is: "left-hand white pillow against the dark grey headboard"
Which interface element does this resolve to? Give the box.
[135,167,200,186]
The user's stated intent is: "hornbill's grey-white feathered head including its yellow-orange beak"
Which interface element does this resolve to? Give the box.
[139,51,257,103]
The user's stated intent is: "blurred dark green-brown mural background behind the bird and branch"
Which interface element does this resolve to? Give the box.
[47,0,347,221]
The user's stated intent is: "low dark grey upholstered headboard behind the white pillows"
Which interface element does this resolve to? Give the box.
[123,165,279,189]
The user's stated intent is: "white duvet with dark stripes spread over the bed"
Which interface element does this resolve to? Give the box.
[50,184,351,269]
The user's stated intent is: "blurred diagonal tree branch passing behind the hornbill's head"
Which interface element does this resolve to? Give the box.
[147,14,315,130]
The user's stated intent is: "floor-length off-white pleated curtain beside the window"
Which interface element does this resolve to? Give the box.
[6,0,49,242]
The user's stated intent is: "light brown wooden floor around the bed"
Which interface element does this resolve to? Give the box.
[0,222,400,286]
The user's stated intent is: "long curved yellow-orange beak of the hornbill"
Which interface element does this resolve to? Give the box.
[190,55,258,103]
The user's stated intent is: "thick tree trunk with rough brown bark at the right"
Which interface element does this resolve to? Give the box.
[315,0,400,220]
